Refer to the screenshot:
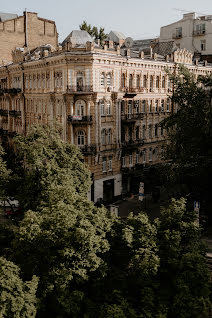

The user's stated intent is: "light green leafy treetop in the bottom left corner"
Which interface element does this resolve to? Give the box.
[0,257,38,318]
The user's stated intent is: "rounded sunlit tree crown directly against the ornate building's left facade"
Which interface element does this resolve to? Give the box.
[13,125,91,210]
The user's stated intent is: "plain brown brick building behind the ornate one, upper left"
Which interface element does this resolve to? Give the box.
[0,11,58,65]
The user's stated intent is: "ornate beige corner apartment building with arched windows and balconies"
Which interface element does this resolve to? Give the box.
[0,36,212,202]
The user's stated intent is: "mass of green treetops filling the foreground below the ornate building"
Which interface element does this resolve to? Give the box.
[0,126,210,318]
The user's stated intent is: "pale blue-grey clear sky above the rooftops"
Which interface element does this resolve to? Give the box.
[0,0,212,42]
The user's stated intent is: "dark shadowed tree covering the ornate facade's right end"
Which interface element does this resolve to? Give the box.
[161,65,212,213]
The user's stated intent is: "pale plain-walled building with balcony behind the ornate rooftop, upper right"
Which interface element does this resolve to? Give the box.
[159,12,212,62]
